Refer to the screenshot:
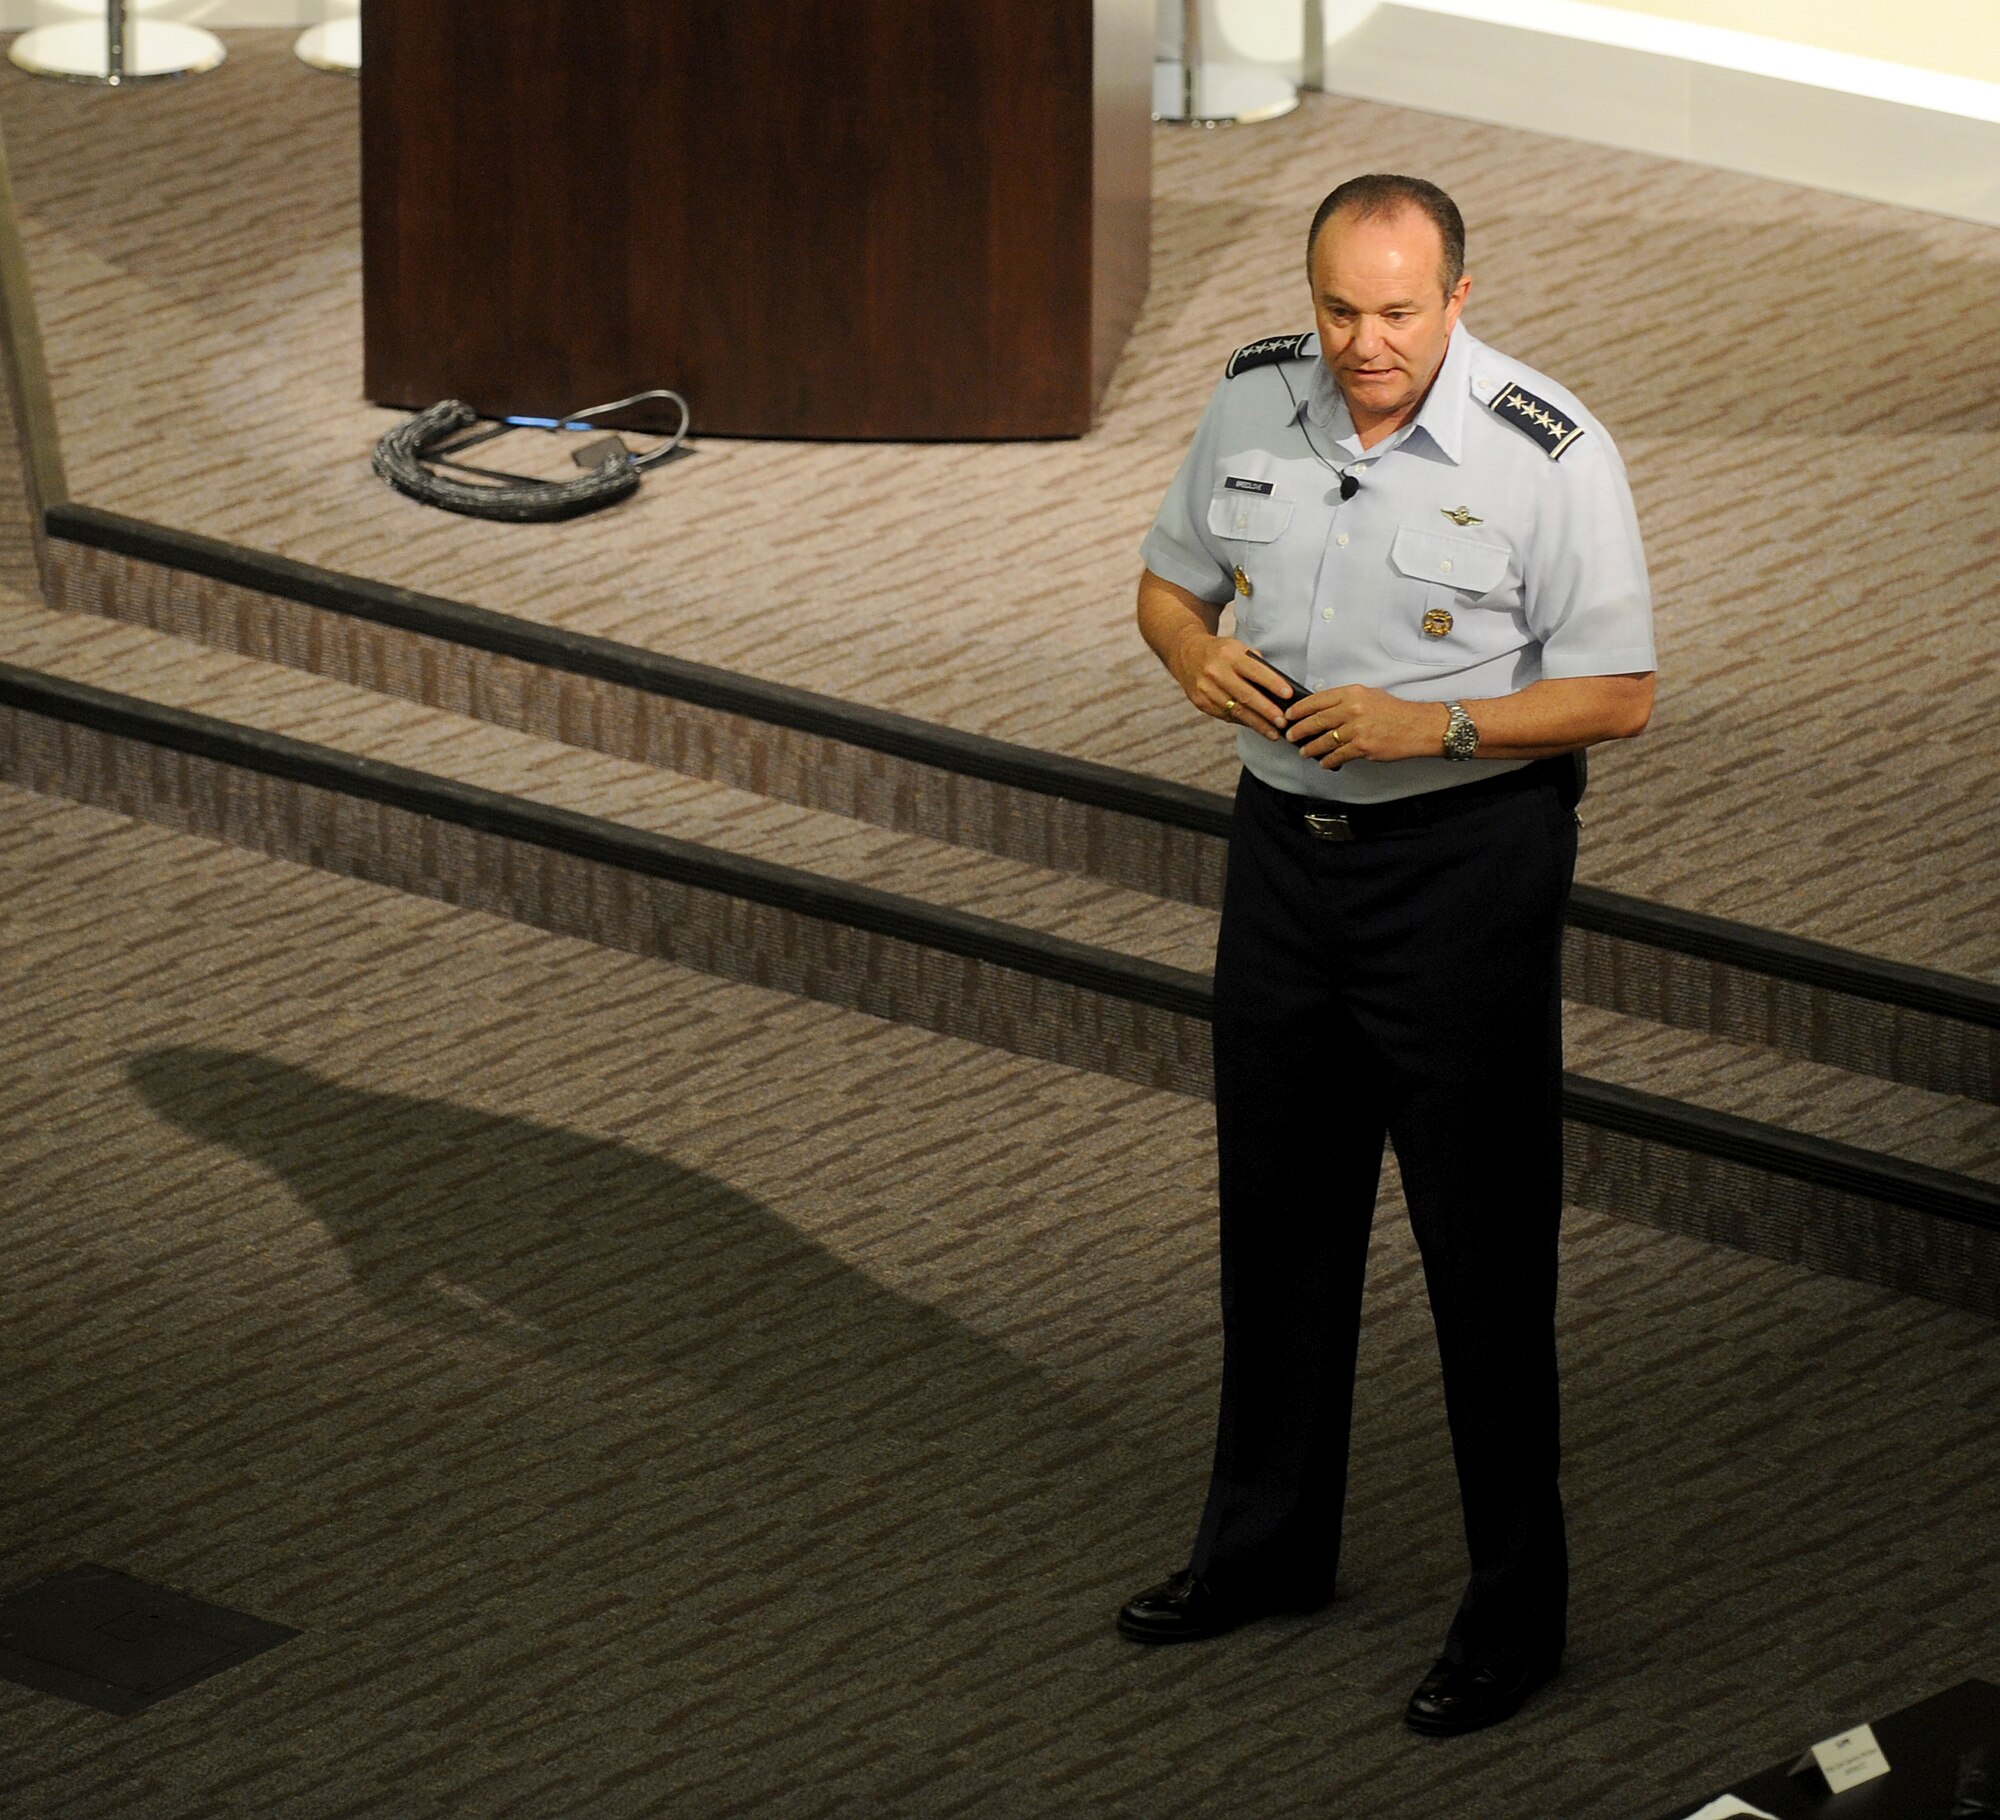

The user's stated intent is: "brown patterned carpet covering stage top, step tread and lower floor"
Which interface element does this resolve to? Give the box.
[0,32,2000,1820]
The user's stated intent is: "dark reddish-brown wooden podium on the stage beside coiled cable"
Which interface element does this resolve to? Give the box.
[362,0,1154,440]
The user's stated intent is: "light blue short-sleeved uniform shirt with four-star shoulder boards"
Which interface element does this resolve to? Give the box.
[1140,324,1654,802]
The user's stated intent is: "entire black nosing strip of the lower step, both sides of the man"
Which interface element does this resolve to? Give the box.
[0,664,2000,1232]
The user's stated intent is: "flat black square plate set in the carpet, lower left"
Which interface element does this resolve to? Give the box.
[0,1566,298,1712]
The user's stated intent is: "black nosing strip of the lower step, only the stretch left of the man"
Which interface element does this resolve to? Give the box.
[0,664,1210,1018]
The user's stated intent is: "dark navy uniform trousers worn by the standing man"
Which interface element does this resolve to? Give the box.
[1190,762,1576,1660]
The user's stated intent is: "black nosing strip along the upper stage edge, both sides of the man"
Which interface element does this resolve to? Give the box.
[46,504,2000,1030]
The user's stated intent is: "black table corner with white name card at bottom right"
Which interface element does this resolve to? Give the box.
[1662,1680,2000,1820]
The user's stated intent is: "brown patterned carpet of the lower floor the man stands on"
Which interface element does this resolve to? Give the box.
[0,790,2000,1820]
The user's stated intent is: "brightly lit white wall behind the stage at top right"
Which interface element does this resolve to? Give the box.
[1162,0,2000,226]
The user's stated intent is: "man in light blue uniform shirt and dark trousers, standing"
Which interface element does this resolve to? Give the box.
[1118,176,1654,1732]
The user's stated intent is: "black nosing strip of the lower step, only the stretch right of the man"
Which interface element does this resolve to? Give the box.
[1562,1074,2000,1232]
